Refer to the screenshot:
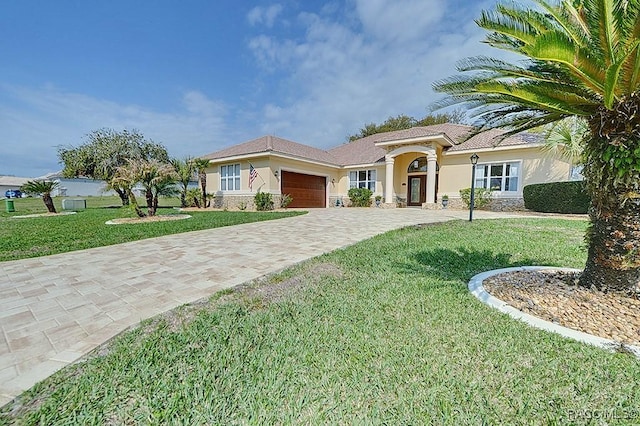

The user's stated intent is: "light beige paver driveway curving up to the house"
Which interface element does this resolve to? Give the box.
[0,208,507,406]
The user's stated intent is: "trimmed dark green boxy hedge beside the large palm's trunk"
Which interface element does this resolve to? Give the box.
[522,181,591,214]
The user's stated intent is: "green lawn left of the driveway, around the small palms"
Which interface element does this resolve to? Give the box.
[0,197,300,261]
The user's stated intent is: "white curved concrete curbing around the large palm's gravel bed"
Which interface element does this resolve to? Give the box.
[468,266,640,358]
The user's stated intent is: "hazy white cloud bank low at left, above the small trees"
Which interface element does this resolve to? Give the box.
[0,85,238,176]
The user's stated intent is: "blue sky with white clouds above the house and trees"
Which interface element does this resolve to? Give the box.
[0,0,499,177]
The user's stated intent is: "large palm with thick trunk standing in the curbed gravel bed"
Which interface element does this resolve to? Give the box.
[434,0,640,292]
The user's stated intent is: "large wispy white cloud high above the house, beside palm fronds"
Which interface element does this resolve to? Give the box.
[249,0,496,147]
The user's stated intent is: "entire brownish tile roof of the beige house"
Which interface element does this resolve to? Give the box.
[203,123,540,166]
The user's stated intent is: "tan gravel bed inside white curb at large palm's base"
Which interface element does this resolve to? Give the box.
[483,269,640,346]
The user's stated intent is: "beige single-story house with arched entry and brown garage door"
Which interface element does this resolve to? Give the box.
[203,123,573,210]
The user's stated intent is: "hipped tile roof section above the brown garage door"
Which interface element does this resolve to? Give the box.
[202,136,338,164]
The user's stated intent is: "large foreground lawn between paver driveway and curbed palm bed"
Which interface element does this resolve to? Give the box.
[5,219,640,425]
